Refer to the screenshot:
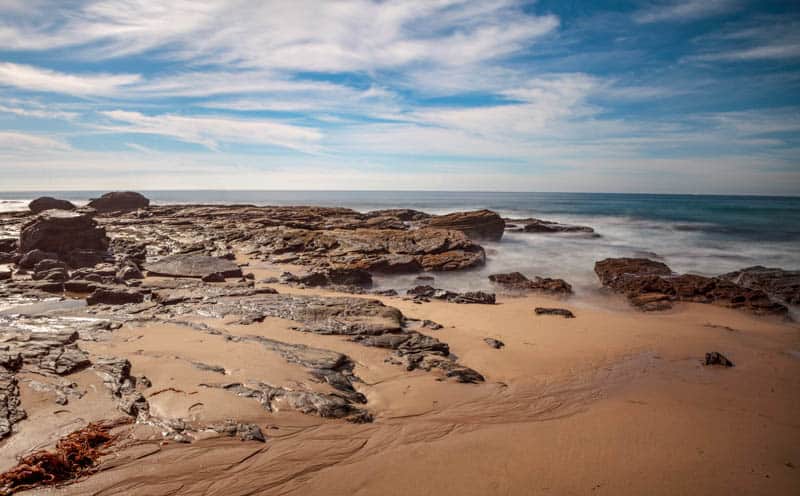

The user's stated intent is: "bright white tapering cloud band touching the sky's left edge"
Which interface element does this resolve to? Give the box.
[0,62,141,96]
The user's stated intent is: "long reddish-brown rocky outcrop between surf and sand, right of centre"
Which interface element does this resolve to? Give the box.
[595,258,788,315]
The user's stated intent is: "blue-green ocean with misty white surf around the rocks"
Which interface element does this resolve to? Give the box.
[0,191,800,294]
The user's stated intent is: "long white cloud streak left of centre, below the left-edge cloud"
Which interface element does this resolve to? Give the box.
[99,110,322,152]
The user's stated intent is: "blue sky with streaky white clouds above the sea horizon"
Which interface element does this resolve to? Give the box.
[0,0,800,195]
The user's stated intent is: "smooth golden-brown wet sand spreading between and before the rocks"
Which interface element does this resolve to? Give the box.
[0,258,800,496]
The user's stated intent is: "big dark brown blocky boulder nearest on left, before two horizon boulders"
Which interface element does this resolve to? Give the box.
[19,210,108,263]
